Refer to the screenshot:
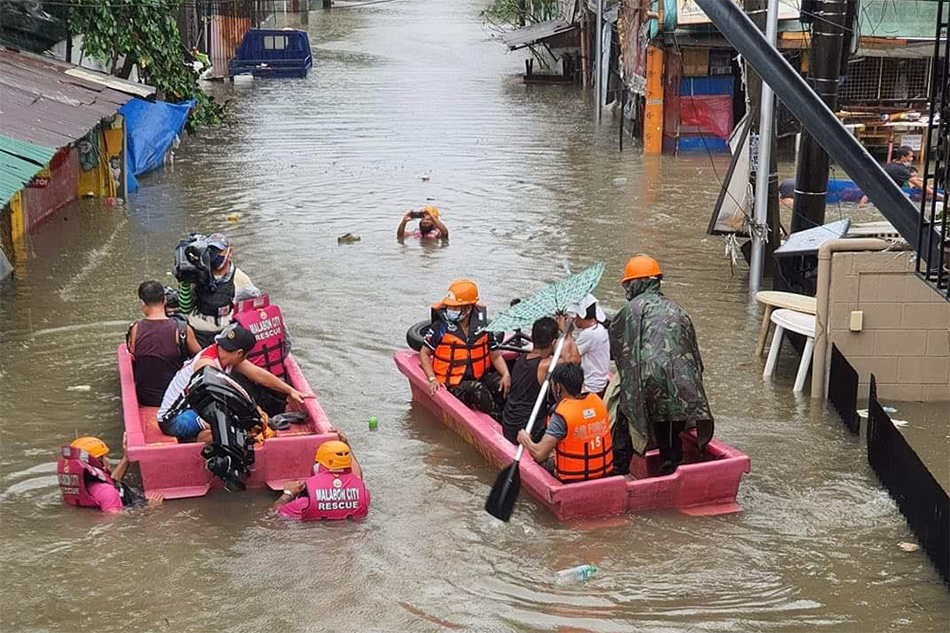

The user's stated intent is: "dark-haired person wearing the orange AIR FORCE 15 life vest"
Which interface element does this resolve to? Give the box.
[518,363,614,483]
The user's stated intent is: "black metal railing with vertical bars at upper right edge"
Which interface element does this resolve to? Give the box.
[916,0,950,301]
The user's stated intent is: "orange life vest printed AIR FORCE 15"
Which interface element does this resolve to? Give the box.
[554,393,614,482]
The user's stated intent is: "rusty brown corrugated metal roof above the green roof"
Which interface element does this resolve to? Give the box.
[0,48,154,149]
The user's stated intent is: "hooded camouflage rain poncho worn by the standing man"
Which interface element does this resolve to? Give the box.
[610,279,713,455]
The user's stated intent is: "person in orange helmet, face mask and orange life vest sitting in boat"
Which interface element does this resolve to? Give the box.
[419,279,511,420]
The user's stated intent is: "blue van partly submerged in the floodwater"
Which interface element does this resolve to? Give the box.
[228,29,313,77]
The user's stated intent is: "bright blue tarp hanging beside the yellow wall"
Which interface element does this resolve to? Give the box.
[119,99,195,192]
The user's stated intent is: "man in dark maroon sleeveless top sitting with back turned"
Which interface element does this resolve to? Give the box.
[125,281,201,407]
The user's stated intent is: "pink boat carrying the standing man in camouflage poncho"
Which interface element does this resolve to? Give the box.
[394,350,750,521]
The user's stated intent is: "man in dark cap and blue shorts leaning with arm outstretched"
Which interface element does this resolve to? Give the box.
[158,323,315,444]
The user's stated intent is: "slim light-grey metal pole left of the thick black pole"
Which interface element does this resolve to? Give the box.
[746,0,778,293]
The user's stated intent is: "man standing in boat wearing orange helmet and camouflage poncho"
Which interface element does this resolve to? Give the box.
[610,255,713,475]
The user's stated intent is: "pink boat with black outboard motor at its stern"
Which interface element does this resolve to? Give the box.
[118,343,339,499]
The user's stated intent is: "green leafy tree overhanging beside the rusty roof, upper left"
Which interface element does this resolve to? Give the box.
[66,0,227,130]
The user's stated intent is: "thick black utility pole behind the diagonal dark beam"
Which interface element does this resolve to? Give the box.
[790,0,849,233]
